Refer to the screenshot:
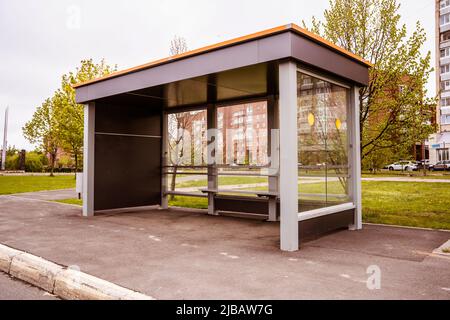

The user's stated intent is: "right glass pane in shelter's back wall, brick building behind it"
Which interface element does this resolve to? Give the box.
[216,101,268,196]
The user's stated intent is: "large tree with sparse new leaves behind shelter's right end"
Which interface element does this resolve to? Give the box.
[303,0,436,165]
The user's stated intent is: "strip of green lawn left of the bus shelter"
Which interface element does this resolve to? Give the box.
[0,175,75,195]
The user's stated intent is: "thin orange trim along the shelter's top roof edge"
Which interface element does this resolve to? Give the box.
[72,23,373,88]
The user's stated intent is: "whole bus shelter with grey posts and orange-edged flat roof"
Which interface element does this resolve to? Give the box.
[75,24,371,251]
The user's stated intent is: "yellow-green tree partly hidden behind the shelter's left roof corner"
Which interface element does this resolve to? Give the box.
[52,59,117,172]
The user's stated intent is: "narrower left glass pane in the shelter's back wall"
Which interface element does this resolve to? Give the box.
[165,110,208,193]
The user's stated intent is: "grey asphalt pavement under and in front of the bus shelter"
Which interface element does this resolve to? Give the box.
[0,196,450,299]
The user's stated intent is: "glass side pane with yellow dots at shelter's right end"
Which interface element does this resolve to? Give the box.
[297,73,350,212]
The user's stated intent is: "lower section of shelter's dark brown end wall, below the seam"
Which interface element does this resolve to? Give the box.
[94,134,161,210]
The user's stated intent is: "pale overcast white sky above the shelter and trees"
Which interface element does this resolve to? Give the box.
[0,0,436,150]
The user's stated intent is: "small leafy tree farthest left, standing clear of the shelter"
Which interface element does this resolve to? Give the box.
[22,99,61,176]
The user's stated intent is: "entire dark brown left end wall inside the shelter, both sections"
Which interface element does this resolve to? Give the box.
[94,103,161,210]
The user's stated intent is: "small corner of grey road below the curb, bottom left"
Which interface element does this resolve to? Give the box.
[0,272,57,300]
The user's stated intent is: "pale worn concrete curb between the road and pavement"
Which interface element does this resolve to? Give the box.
[0,244,155,300]
